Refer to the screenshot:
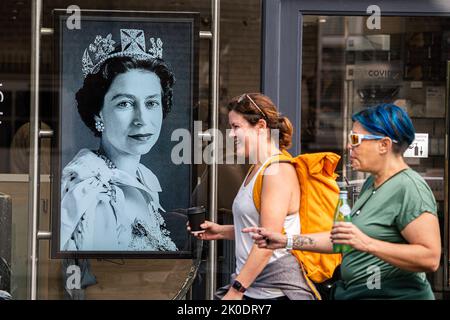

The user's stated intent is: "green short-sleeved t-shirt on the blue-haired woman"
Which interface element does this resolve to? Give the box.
[336,169,437,299]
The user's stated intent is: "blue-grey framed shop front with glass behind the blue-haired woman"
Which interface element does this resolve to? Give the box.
[262,0,450,297]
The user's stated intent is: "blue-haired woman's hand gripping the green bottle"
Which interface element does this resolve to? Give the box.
[330,222,373,252]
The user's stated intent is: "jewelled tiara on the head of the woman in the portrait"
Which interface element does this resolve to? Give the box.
[81,29,163,78]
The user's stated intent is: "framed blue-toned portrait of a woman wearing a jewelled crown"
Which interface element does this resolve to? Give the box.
[52,10,199,258]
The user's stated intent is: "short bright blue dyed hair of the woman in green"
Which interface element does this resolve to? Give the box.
[352,103,416,154]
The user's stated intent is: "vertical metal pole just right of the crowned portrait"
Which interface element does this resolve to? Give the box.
[206,0,220,300]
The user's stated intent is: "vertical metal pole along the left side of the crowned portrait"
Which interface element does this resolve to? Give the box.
[28,0,42,300]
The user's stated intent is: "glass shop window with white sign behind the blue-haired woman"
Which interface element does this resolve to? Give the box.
[301,16,450,291]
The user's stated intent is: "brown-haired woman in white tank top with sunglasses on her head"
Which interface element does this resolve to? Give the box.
[188,93,316,300]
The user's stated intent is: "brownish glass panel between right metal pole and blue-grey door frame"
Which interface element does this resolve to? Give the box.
[217,0,261,287]
